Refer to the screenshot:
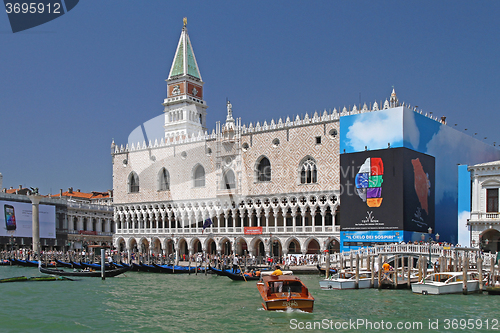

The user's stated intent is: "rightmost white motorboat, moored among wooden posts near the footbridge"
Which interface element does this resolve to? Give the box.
[411,272,479,295]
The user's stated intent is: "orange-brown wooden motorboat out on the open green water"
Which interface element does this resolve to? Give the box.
[257,271,314,312]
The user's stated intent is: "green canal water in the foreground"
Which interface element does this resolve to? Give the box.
[0,266,500,333]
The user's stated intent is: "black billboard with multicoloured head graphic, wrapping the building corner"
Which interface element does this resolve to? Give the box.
[340,148,435,233]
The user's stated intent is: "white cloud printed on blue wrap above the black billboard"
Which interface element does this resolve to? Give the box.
[346,110,403,151]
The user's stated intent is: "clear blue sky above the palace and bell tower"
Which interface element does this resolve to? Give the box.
[0,0,500,193]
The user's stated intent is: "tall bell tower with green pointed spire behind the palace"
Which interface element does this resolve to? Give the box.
[163,18,208,138]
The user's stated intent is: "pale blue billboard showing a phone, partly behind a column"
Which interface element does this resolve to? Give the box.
[0,201,56,238]
